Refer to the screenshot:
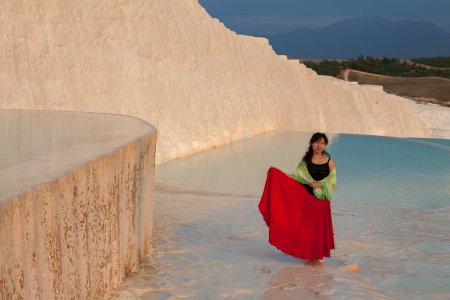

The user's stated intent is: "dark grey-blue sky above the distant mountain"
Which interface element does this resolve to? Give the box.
[199,0,450,35]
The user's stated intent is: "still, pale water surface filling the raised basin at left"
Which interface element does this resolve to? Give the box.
[0,109,152,202]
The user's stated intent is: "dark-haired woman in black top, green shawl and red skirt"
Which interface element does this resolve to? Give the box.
[258,132,336,261]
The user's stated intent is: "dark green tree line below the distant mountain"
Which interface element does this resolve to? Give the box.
[303,55,450,78]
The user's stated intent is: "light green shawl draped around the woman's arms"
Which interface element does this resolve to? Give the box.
[292,161,336,201]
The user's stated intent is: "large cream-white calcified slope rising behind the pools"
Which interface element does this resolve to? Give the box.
[0,0,450,162]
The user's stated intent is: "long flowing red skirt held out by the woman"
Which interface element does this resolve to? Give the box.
[258,167,334,260]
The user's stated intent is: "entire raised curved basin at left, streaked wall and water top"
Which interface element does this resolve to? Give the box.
[0,110,156,299]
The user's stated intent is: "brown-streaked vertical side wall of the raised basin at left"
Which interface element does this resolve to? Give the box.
[0,131,156,299]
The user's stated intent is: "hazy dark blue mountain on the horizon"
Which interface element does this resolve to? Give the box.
[267,17,450,59]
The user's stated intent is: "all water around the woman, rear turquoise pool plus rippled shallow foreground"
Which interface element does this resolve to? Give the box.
[116,132,450,299]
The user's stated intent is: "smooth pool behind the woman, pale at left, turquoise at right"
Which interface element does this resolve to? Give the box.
[156,132,450,207]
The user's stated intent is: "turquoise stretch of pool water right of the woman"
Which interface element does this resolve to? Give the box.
[329,135,450,208]
